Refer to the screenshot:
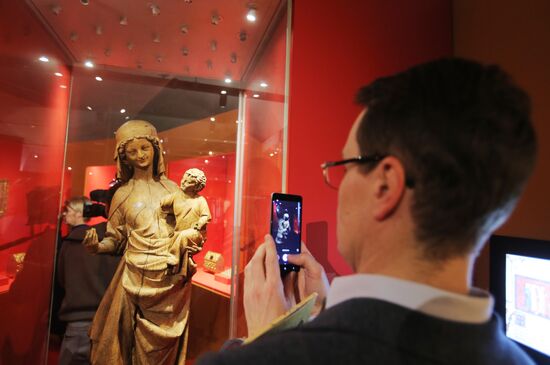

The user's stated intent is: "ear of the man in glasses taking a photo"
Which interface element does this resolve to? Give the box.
[372,156,405,220]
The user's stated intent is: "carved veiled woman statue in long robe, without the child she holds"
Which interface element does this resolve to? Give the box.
[83,120,191,365]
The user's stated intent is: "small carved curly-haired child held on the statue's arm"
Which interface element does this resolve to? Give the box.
[160,168,212,277]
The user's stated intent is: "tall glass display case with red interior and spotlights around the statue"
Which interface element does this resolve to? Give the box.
[0,0,291,364]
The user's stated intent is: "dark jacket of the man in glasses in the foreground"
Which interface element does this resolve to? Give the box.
[197,298,534,365]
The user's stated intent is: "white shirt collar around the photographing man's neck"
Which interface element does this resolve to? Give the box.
[326,274,493,323]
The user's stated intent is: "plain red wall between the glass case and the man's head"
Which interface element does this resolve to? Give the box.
[288,0,452,275]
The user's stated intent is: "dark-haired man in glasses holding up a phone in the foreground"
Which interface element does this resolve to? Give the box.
[199,59,536,364]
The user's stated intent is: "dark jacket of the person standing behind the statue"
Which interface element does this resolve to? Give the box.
[56,223,120,322]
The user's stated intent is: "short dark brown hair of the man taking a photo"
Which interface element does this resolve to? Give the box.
[357,58,537,260]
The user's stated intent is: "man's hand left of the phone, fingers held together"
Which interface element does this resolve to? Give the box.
[243,235,290,337]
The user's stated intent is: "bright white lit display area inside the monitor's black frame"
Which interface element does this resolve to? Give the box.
[505,254,550,356]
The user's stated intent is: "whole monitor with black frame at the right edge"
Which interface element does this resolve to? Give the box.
[489,235,550,364]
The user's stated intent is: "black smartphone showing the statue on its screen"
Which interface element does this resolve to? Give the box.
[271,193,302,276]
